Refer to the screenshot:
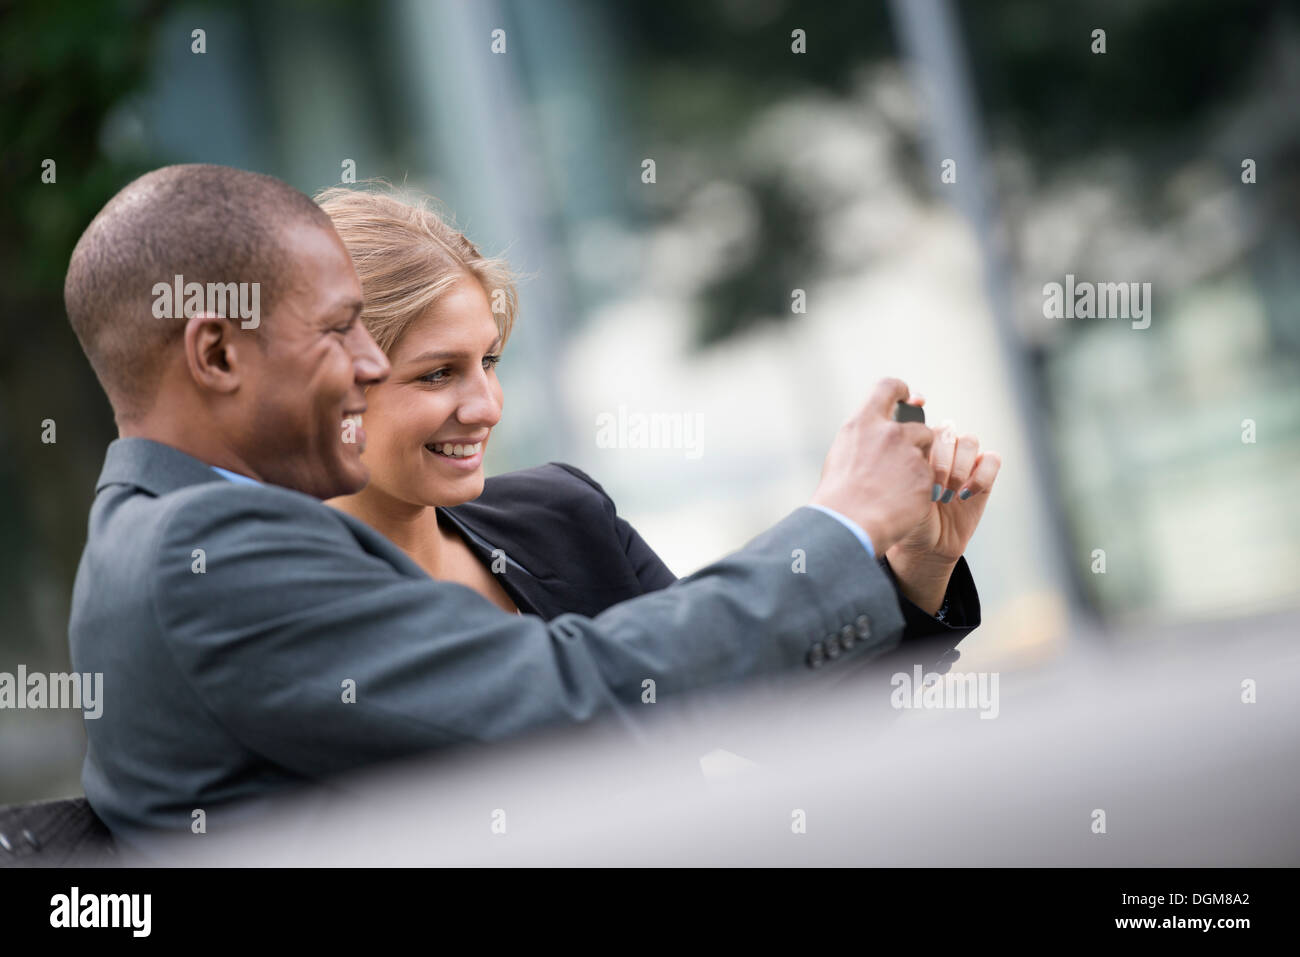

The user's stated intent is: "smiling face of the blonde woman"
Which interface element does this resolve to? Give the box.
[363,276,502,506]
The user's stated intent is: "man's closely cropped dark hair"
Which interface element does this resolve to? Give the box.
[64,164,333,421]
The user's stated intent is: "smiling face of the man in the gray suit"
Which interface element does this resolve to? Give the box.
[239,224,389,498]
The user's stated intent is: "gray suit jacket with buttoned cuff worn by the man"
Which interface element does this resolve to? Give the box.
[69,438,904,840]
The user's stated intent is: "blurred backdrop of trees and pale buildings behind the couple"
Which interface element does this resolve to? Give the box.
[0,0,1300,802]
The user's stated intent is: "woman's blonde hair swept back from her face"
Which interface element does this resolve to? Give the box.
[316,181,519,352]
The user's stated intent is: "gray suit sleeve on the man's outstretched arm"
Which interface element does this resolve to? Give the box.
[151,482,904,778]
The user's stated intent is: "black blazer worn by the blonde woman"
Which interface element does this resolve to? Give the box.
[438,462,980,672]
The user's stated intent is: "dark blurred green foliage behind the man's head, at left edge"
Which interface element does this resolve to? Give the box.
[0,0,159,655]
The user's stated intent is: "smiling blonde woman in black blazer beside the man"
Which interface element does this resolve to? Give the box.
[316,180,996,657]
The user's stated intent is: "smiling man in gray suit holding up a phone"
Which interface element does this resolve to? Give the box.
[65,165,996,841]
